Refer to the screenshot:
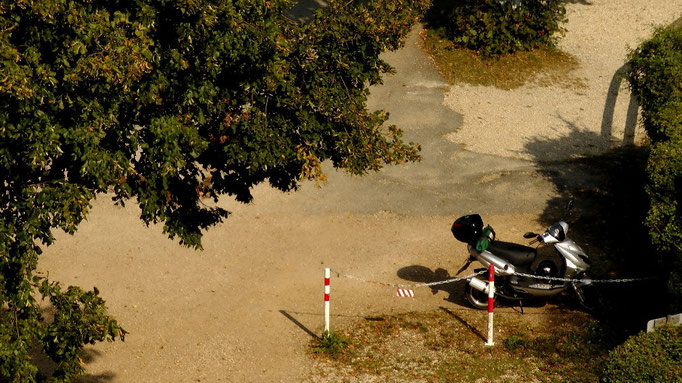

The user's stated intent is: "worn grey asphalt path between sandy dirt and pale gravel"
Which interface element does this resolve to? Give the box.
[244,28,556,219]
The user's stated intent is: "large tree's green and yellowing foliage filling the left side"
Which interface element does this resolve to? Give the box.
[0,0,428,382]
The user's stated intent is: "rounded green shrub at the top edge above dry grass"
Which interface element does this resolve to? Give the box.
[427,0,566,56]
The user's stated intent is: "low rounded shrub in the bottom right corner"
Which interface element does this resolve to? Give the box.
[602,326,682,383]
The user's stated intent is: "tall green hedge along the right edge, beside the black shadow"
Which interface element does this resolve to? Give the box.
[628,19,682,309]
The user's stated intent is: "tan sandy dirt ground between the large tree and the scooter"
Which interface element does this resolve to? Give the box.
[41,200,537,382]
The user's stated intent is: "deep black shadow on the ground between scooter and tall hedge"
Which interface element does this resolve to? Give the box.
[525,121,666,338]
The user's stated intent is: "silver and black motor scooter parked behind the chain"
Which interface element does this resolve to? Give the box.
[452,200,596,310]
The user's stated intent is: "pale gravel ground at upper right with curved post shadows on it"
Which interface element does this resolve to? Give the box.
[444,0,682,161]
